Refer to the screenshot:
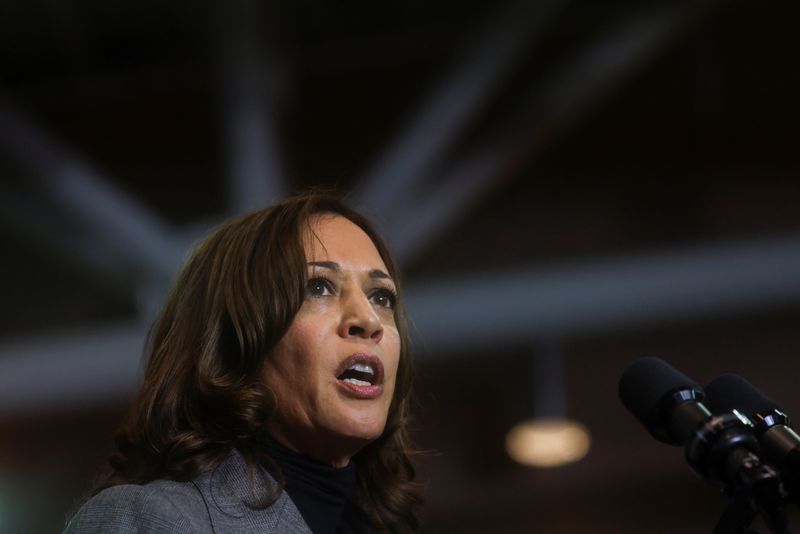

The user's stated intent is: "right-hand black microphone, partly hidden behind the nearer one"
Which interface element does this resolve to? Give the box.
[706,374,800,501]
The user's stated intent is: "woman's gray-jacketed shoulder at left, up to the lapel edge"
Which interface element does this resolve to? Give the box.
[65,481,200,534]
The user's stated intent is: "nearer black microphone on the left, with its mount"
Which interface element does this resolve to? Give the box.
[619,357,781,494]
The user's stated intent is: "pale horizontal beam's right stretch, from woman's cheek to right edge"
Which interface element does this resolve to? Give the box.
[406,236,800,358]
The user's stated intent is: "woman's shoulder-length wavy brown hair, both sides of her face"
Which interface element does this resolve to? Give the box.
[95,191,421,531]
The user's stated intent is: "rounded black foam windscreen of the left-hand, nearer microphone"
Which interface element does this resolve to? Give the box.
[619,357,703,442]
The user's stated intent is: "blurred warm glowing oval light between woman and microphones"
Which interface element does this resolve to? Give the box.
[506,417,591,467]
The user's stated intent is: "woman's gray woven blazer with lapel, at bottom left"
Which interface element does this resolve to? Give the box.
[64,451,311,534]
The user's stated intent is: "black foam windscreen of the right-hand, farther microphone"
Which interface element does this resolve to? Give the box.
[706,373,783,422]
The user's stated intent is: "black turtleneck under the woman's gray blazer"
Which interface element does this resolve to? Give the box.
[261,435,376,534]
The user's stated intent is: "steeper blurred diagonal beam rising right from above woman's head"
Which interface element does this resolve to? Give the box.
[354,0,568,216]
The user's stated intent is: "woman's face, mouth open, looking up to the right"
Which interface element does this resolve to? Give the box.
[264,214,400,466]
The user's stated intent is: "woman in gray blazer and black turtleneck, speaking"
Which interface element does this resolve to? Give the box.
[66,192,421,534]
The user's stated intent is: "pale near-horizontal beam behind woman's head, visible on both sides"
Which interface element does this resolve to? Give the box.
[0,236,800,415]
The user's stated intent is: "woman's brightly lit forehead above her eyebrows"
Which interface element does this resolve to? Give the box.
[303,213,386,271]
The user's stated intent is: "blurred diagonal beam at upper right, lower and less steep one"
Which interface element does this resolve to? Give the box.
[384,0,720,263]
